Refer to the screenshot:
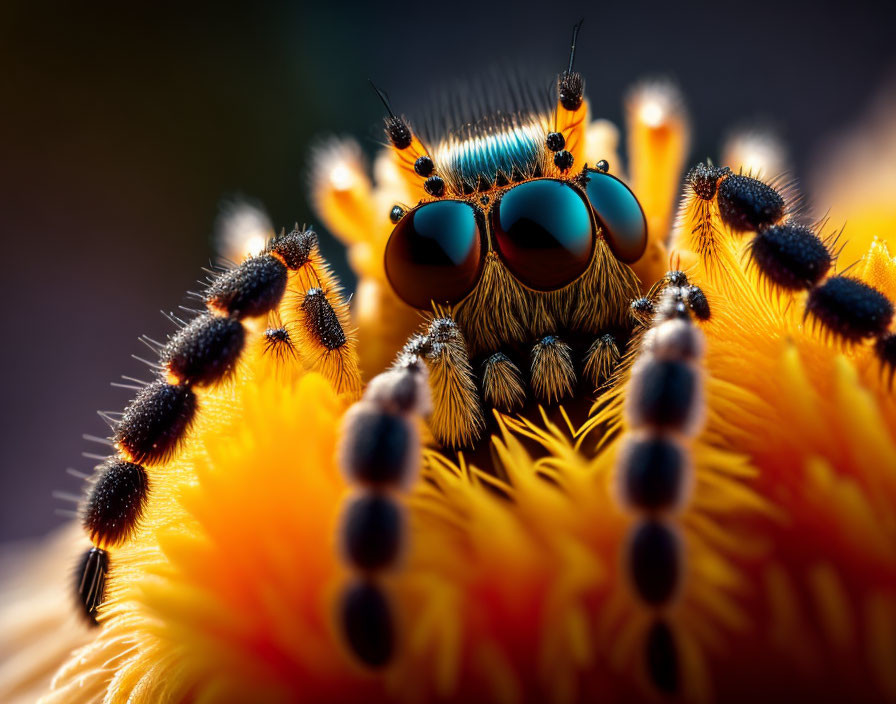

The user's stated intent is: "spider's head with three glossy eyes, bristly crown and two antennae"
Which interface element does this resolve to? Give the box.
[378,23,647,355]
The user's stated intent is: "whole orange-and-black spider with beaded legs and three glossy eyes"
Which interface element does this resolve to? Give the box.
[63,27,896,704]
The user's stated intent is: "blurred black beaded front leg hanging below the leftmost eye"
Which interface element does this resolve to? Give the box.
[337,350,431,668]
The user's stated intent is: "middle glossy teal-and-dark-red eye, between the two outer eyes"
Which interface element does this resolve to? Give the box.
[493,179,594,291]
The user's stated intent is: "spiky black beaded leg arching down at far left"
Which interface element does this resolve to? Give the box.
[75,228,324,623]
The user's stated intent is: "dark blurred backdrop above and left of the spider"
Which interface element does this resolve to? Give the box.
[0,0,896,540]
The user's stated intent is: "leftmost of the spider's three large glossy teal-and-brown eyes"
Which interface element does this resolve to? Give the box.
[386,200,482,308]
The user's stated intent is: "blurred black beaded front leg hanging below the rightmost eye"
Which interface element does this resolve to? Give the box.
[616,286,704,694]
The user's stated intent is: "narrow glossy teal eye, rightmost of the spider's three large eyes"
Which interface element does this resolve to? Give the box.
[585,170,647,264]
